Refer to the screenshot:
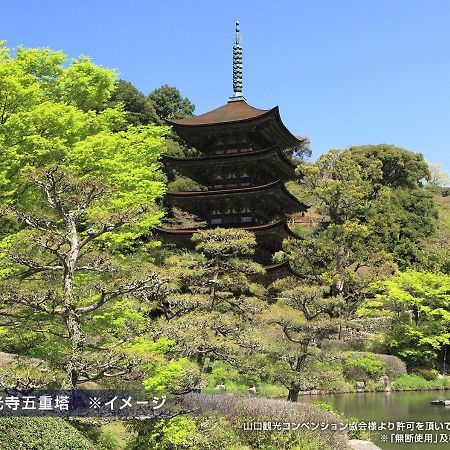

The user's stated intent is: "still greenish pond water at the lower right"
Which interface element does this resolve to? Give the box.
[299,391,450,450]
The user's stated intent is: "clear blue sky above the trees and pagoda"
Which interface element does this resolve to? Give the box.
[0,0,450,172]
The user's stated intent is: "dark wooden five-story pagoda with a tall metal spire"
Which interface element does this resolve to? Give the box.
[157,22,307,276]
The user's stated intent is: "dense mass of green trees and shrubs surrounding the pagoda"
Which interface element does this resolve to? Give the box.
[0,47,450,450]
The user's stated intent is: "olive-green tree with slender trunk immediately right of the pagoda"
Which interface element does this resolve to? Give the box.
[288,150,395,338]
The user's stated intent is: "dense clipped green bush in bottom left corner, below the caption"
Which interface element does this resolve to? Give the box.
[0,417,95,450]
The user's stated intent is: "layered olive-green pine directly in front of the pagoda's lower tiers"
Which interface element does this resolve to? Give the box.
[150,228,265,368]
